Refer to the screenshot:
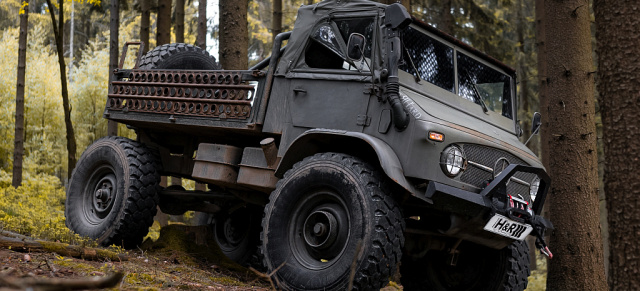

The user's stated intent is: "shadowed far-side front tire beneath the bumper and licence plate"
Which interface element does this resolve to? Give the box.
[400,241,531,291]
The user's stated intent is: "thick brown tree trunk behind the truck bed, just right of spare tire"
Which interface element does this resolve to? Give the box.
[219,0,249,70]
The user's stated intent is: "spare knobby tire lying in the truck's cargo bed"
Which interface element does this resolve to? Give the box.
[140,43,221,70]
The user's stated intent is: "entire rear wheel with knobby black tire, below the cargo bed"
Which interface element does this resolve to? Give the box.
[65,137,161,248]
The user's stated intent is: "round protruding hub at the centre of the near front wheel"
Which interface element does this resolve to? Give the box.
[303,210,338,249]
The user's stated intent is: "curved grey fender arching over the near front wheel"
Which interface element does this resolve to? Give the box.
[275,129,418,195]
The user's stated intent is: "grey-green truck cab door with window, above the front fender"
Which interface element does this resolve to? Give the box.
[287,17,375,131]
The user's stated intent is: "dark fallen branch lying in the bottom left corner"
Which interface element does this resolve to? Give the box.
[0,273,123,291]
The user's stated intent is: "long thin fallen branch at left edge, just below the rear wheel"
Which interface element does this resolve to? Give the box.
[0,231,129,261]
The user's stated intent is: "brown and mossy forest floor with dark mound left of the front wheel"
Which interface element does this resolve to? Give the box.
[0,227,272,290]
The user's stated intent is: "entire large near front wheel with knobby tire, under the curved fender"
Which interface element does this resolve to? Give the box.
[261,153,404,290]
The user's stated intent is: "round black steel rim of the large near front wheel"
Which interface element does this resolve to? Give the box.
[288,189,351,270]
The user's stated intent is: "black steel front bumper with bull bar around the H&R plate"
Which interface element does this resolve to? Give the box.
[425,164,553,248]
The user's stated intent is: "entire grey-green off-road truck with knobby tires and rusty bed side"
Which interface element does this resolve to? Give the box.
[66,0,551,290]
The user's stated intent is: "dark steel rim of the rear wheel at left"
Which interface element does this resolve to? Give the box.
[82,164,119,225]
